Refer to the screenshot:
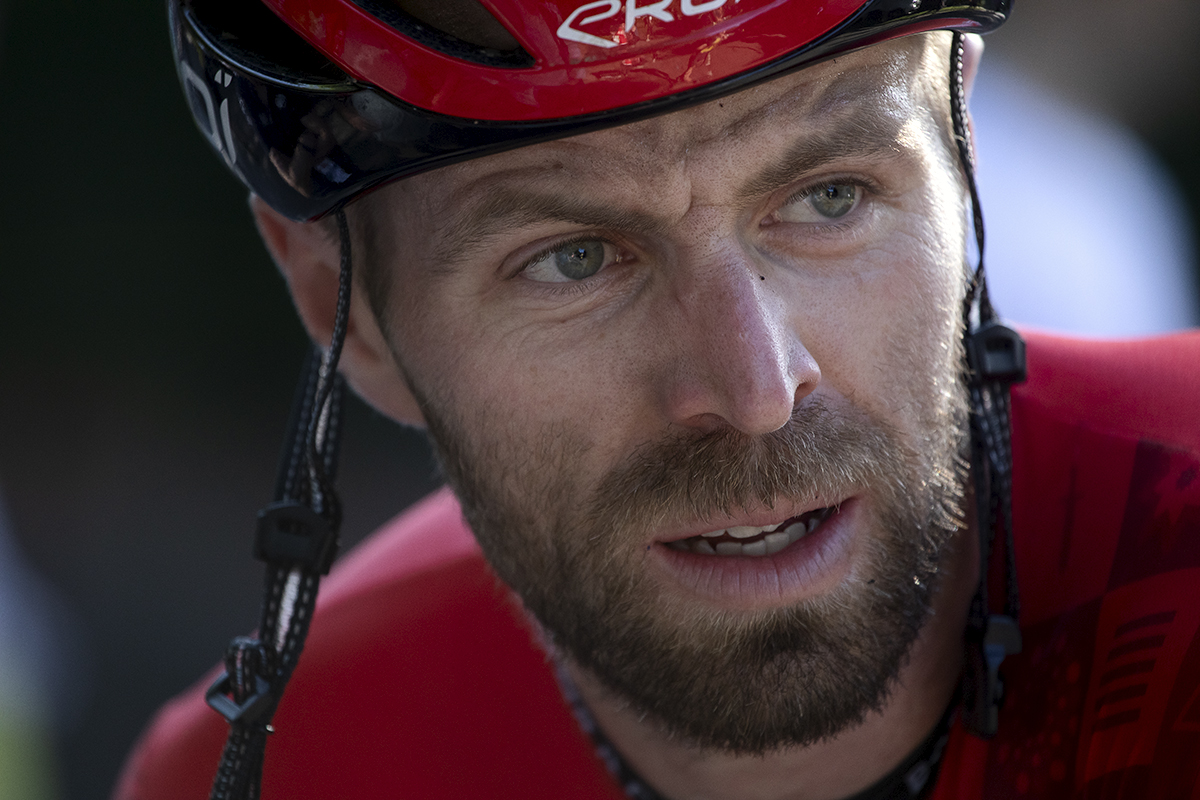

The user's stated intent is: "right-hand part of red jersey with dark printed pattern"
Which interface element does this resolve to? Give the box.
[936,333,1200,800]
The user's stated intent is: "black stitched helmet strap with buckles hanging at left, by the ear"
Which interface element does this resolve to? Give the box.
[205,210,352,800]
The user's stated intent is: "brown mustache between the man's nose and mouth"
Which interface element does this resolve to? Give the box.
[587,396,912,537]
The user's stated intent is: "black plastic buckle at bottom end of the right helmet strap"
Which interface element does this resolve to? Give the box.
[962,614,1021,739]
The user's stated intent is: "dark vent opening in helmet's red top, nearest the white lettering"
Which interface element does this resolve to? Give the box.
[352,0,535,68]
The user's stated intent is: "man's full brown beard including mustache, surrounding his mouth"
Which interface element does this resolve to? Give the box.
[414,374,966,754]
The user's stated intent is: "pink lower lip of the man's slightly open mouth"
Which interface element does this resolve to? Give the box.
[650,498,859,610]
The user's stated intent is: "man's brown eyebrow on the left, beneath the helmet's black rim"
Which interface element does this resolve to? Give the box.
[433,187,666,267]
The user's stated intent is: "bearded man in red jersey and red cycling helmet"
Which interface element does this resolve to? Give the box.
[118,0,1200,800]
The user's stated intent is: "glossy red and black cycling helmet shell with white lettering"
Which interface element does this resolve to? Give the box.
[169,0,1010,219]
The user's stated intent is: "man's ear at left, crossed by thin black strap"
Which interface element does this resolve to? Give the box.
[250,194,425,427]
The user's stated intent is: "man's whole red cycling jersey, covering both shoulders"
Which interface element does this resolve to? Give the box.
[116,333,1200,800]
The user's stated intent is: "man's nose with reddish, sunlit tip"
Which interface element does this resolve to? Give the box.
[660,242,821,435]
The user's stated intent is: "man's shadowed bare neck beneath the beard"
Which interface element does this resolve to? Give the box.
[565,529,979,800]
